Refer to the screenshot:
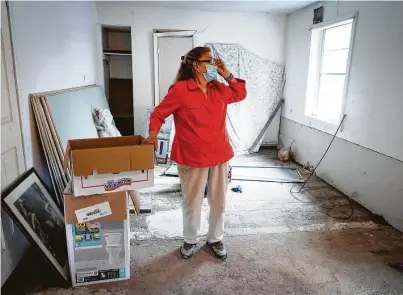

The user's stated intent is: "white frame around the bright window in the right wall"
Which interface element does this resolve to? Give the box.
[305,12,358,125]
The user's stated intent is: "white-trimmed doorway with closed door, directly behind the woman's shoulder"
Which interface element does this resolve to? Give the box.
[154,30,196,163]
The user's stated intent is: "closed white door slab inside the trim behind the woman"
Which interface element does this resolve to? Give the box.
[158,37,193,153]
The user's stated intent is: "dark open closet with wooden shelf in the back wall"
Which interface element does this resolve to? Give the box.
[102,26,134,136]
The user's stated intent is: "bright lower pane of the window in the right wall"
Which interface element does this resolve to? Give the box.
[316,75,345,121]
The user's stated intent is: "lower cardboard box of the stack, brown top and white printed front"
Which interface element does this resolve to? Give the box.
[64,187,130,286]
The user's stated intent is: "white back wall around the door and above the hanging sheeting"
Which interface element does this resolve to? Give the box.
[98,3,285,142]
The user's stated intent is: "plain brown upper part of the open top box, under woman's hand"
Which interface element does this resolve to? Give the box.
[64,135,154,176]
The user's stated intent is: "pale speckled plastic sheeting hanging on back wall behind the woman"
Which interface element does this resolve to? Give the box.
[206,43,285,155]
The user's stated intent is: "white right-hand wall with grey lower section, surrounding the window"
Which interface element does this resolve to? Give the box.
[280,1,403,234]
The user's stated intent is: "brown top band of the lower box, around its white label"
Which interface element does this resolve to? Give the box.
[64,190,127,224]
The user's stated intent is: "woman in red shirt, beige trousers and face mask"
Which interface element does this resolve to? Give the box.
[144,47,246,260]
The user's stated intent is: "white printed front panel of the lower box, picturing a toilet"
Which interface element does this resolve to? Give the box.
[66,219,130,286]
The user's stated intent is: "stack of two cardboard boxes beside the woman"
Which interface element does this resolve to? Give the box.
[64,136,154,286]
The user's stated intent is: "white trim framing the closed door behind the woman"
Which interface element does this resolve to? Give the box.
[153,30,197,106]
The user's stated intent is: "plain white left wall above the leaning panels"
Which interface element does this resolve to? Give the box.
[10,1,101,174]
